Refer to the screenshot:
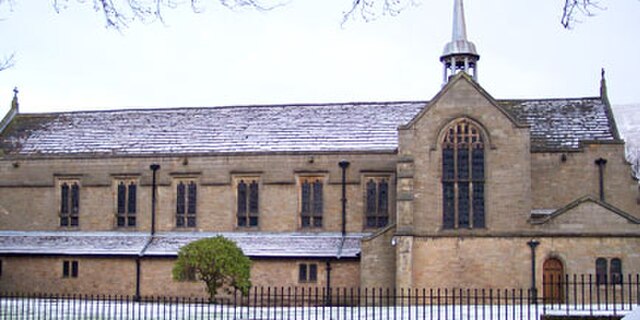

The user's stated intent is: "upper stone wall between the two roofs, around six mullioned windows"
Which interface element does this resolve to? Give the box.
[0,153,395,232]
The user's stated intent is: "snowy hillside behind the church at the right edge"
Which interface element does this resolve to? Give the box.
[613,103,640,178]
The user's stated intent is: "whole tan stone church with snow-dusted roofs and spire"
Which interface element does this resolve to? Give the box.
[0,0,640,296]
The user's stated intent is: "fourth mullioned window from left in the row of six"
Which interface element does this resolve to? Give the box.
[236,178,260,227]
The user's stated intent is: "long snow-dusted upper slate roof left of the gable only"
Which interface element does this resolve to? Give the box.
[0,102,424,155]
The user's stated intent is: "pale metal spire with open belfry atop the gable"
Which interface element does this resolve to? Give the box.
[440,0,480,83]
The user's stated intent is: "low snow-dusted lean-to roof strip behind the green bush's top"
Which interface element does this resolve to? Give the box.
[0,231,366,258]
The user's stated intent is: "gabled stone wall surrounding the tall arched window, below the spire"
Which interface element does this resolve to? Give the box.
[398,77,531,234]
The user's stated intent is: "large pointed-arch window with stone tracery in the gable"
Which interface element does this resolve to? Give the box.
[442,119,485,229]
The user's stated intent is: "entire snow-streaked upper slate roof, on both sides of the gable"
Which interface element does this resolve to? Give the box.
[0,97,616,156]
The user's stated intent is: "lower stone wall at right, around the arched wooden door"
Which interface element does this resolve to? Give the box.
[412,237,640,288]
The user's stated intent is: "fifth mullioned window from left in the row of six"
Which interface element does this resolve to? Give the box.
[300,177,324,228]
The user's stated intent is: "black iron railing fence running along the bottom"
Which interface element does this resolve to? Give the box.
[0,275,640,320]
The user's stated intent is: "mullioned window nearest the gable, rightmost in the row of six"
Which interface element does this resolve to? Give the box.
[365,177,389,228]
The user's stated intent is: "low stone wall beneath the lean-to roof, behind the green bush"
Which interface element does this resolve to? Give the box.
[0,256,360,298]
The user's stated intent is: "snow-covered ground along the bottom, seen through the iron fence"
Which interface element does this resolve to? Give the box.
[0,298,637,320]
